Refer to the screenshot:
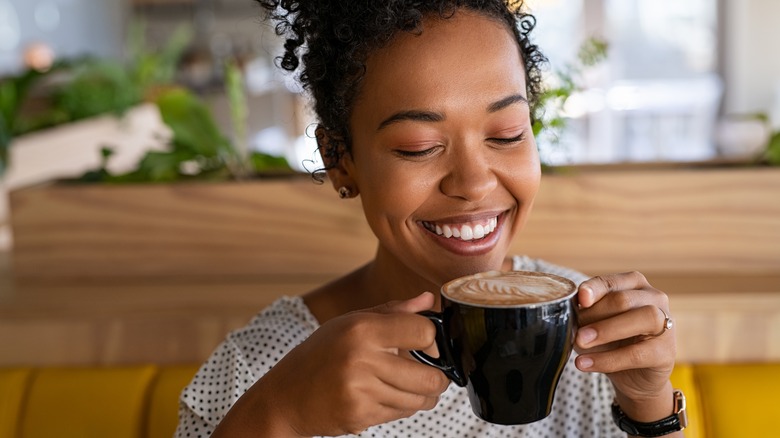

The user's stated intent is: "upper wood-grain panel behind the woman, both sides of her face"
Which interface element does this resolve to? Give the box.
[11,168,780,280]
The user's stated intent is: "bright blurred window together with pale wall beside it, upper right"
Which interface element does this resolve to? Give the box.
[531,0,780,164]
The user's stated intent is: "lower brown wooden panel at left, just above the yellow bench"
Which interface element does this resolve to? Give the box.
[0,278,327,366]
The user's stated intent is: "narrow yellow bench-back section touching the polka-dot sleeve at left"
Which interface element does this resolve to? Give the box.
[146,365,198,438]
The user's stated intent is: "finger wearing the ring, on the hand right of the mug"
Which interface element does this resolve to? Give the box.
[576,305,666,349]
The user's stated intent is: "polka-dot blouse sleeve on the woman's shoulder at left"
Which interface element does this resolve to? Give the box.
[181,297,319,425]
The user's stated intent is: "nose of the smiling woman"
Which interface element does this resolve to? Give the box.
[440,147,498,202]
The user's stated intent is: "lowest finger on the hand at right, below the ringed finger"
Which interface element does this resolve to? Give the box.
[575,338,675,374]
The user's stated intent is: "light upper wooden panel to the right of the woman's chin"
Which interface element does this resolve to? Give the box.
[513,168,780,273]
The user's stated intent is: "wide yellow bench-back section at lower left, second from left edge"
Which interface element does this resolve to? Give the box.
[20,366,157,438]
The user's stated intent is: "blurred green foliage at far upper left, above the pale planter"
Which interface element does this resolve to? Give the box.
[0,23,192,177]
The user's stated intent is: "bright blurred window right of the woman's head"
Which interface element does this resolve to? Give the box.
[529,0,723,164]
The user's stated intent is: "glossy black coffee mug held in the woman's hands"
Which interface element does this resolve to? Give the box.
[411,271,577,425]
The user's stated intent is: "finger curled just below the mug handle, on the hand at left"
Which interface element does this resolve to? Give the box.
[376,356,450,397]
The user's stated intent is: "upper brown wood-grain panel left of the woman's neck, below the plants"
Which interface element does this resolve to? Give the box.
[11,177,374,279]
